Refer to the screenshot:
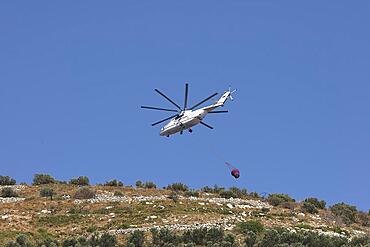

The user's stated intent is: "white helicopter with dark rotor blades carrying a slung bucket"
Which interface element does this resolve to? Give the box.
[141,83,236,137]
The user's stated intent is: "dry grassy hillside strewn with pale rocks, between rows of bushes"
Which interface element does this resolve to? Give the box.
[0,179,370,246]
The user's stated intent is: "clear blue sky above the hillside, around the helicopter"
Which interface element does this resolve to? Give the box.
[0,0,370,210]
